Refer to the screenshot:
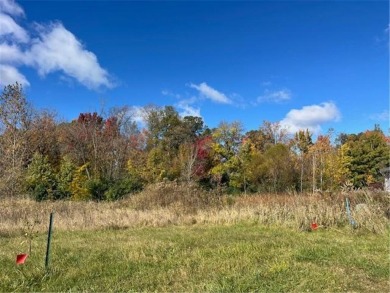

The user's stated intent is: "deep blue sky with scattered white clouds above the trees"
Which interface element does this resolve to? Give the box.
[0,0,389,134]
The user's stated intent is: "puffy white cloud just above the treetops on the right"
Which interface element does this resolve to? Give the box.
[280,102,341,133]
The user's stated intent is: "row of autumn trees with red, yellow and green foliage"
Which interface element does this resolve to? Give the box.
[0,83,390,200]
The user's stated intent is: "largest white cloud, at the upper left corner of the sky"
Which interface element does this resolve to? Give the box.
[0,0,114,90]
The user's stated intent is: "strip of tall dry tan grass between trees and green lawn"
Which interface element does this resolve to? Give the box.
[0,183,390,236]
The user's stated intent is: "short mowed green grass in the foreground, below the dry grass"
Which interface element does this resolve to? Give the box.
[0,223,390,292]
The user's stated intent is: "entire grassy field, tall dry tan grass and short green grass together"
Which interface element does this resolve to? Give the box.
[0,186,390,292]
